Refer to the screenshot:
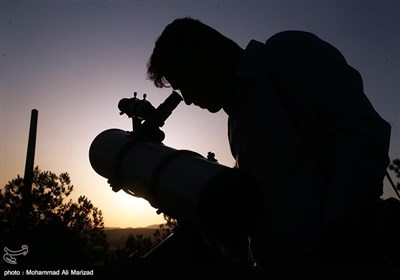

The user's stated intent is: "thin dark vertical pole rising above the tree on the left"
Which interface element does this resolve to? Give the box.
[21,109,38,227]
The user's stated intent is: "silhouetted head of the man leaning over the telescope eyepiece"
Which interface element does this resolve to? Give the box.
[147,18,242,112]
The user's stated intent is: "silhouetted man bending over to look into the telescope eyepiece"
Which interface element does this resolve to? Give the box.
[147,18,390,267]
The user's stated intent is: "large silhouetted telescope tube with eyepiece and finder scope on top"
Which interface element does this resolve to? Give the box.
[89,91,263,240]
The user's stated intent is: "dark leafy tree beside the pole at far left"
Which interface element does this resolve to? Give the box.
[0,167,107,267]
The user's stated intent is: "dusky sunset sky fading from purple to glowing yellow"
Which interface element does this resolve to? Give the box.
[0,0,400,227]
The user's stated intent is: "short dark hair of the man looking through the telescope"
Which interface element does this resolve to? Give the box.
[147,17,237,88]
